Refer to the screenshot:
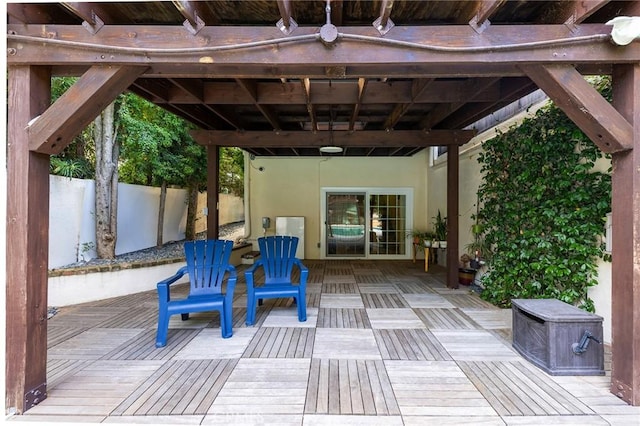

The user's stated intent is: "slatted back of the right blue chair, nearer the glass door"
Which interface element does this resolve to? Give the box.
[258,235,298,284]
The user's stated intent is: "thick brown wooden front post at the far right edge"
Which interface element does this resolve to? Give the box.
[611,64,640,405]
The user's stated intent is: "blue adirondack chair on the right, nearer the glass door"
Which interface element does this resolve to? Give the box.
[244,236,309,325]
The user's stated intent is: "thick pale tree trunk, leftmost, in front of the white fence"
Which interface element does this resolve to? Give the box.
[94,103,120,259]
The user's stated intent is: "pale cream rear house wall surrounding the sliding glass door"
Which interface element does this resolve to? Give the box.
[245,151,428,259]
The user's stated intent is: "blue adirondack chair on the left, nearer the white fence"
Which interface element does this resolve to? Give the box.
[156,240,237,347]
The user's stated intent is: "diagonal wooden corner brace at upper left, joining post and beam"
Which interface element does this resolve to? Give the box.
[29,65,145,154]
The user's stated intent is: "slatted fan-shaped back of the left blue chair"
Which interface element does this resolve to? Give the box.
[184,240,233,296]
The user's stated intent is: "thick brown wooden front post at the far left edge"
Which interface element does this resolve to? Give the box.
[5,66,51,413]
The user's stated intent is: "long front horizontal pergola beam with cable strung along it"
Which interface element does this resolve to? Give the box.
[7,24,640,68]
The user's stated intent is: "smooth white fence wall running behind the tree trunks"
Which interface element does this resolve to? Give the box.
[49,175,244,269]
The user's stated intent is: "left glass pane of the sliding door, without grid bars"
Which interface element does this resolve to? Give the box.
[326,193,365,256]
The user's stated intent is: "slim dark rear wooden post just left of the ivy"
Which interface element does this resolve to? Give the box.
[447,145,460,288]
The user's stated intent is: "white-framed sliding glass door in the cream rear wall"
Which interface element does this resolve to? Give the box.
[322,188,413,259]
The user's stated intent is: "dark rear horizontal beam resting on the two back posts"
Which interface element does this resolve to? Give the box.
[190,130,475,148]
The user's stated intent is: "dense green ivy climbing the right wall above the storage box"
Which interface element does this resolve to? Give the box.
[478,77,611,312]
